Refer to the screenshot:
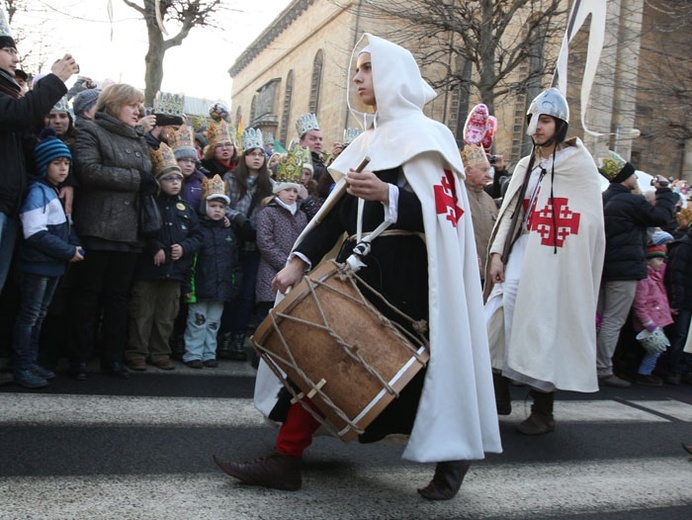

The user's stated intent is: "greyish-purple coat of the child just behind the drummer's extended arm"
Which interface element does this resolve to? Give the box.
[255,200,308,302]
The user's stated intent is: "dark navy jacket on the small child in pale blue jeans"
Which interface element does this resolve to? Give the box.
[189,216,241,302]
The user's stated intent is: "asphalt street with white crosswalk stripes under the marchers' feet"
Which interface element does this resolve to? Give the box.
[0,360,692,520]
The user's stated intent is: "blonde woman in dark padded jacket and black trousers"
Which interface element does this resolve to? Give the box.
[71,83,153,380]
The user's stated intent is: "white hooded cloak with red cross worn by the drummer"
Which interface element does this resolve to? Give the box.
[255,34,502,462]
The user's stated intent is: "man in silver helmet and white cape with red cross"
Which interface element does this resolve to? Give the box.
[485,88,605,435]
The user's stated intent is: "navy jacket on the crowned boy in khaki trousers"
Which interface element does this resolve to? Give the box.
[135,194,202,294]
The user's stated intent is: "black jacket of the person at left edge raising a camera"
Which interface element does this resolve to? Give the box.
[0,71,67,216]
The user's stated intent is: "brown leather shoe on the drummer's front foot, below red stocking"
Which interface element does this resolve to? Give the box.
[214,451,302,491]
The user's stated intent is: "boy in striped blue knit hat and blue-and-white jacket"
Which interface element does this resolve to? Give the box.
[12,129,84,388]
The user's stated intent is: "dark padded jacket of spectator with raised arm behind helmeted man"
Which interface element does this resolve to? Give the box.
[602,183,677,280]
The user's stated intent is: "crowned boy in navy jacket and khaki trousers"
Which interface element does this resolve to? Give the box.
[125,143,201,371]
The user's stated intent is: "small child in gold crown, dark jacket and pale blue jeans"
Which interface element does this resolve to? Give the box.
[183,175,240,368]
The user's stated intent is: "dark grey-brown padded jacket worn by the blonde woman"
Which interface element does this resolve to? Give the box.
[74,112,151,246]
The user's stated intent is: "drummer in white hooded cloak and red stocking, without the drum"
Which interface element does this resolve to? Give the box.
[217,35,501,500]
